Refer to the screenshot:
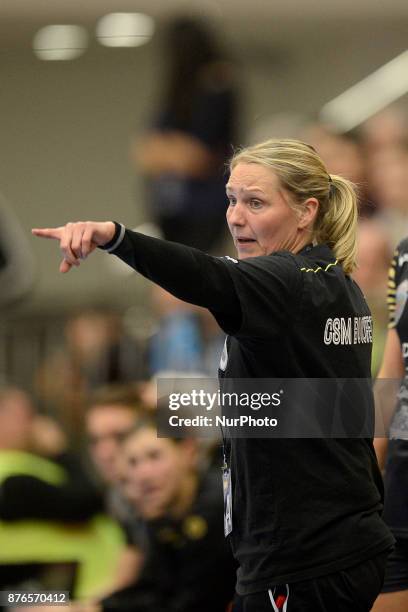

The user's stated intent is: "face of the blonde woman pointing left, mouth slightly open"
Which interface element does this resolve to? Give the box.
[227,163,300,259]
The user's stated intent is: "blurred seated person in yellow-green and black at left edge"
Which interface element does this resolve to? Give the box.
[0,387,123,597]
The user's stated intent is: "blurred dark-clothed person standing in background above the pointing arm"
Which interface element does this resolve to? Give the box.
[134,18,236,251]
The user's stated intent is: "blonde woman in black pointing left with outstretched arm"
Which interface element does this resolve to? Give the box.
[33,140,393,612]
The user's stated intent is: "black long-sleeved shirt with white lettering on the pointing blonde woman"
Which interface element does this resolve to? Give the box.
[105,226,393,594]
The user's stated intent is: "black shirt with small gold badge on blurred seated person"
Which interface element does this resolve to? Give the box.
[102,472,236,612]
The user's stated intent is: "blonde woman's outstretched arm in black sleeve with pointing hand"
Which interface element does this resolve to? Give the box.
[32,221,241,329]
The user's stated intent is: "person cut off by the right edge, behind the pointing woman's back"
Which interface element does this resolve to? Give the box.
[373,239,408,612]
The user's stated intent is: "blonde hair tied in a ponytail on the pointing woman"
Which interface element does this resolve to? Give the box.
[230,139,358,274]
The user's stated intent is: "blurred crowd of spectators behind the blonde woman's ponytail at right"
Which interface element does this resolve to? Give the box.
[299,110,408,376]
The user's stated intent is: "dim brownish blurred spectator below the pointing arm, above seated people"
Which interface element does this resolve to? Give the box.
[37,310,144,446]
